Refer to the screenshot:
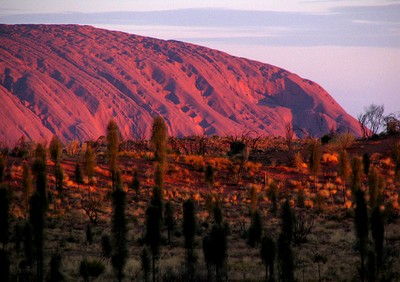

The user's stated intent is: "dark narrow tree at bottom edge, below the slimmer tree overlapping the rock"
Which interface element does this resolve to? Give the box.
[111,189,128,281]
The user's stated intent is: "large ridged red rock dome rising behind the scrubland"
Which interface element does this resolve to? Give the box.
[0,25,360,141]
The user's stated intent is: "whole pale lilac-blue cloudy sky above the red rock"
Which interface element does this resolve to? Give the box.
[0,0,400,116]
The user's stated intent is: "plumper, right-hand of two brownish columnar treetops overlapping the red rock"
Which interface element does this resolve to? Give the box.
[151,116,168,167]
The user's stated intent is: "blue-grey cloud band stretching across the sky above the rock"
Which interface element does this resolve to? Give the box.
[0,4,400,48]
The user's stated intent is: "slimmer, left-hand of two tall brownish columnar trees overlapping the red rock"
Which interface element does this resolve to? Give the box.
[107,120,119,190]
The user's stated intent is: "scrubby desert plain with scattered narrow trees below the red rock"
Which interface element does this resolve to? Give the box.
[0,118,400,281]
